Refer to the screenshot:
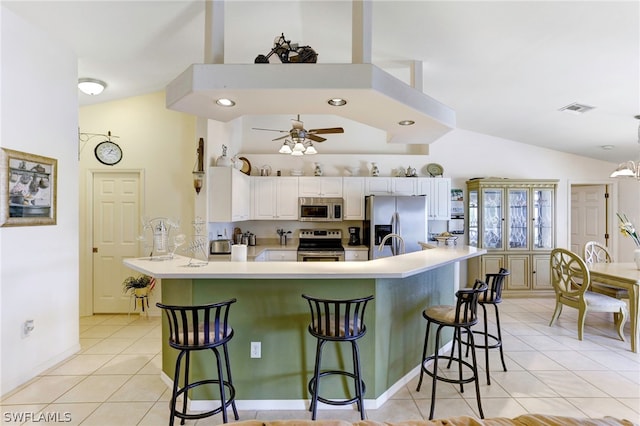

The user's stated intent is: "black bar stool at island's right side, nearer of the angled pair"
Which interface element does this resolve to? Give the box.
[416,280,487,420]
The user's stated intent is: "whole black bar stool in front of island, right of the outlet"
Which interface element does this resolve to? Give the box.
[302,294,373,420]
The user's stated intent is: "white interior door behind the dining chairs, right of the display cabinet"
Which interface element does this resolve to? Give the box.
[571,185,609,257]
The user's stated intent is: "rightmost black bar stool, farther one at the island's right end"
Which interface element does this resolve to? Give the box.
[466,268,509,385]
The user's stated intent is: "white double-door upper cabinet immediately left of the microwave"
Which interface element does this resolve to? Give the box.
[251,176,298,220]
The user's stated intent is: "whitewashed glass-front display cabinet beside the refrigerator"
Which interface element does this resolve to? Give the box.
[466,178,557,291]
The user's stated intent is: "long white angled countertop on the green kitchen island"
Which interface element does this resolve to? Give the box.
[124,245,486,279]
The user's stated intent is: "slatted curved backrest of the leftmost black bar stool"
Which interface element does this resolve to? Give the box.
[156,299,236,350]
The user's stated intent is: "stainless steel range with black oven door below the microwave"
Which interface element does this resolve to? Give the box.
[298,229,344,262]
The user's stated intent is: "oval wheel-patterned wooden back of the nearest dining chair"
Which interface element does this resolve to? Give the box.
[550,248,591,301]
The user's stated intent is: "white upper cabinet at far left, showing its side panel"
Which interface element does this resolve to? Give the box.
[207,167,251,222]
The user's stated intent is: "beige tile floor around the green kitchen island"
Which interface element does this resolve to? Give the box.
[1,298,640,426]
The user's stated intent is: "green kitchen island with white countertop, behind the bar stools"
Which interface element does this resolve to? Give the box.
[124,246,485,410]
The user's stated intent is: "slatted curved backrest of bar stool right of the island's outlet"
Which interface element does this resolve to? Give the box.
[302,294,373,340]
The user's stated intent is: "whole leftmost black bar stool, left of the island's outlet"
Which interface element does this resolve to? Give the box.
[156,299,238,426]
